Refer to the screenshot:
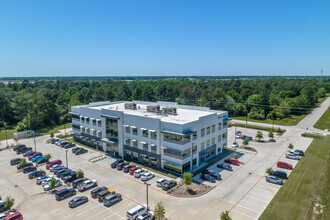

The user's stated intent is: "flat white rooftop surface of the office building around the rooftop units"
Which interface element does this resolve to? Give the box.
[84,101,227,124]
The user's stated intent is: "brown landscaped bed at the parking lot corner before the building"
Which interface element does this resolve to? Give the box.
[168,181,213,197]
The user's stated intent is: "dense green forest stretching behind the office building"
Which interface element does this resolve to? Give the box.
[0,78,330,130]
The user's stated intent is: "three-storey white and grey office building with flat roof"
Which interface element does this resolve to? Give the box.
[70,101,228,174]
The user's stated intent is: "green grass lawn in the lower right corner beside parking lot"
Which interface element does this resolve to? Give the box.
[260,135,330,220]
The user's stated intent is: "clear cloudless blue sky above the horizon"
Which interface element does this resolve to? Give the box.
[0,0,330,77]
